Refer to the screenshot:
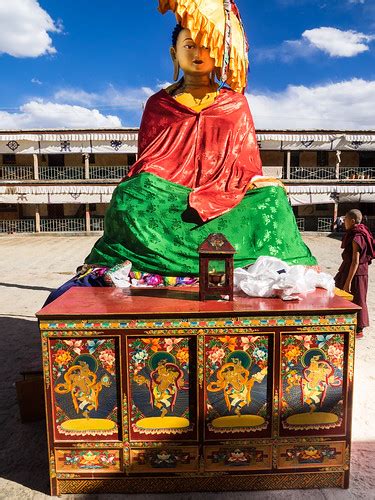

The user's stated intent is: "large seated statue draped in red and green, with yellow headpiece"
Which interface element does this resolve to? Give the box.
[47,0,316,300]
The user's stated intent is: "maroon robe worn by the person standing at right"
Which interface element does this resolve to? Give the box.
[335,224,375,332]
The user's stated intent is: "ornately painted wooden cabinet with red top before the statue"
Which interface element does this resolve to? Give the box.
[38,288,358,494]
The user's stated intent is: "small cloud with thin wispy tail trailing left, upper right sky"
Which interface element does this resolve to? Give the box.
[255,26,375,62]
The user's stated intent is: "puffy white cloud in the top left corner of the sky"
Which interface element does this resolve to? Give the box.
[0,0,61,57]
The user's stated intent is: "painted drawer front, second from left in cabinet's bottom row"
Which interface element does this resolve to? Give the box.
[130,446,199,473]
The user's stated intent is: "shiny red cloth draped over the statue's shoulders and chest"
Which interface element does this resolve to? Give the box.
[128,89,262,221]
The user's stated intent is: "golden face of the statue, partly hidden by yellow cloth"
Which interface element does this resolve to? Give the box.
[171,29,215,76]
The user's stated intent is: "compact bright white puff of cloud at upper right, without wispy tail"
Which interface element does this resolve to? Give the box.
[302,26,375,57]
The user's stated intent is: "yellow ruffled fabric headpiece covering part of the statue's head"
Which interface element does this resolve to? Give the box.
[159,0,249,92]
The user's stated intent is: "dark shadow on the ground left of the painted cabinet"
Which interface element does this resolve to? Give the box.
[0,317,49,494]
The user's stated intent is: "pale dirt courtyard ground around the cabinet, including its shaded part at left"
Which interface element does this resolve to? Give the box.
[0,234,375,500]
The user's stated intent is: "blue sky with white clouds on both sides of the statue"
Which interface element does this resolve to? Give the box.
[0,0,375,129]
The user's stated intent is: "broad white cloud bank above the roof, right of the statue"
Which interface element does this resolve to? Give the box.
[247,78,375,130]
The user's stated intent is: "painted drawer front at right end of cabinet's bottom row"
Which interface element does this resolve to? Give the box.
[277,442,346,469]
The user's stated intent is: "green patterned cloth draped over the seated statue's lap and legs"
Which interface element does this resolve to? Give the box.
[85,172,317,276]
